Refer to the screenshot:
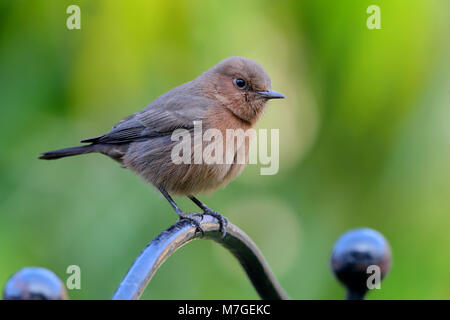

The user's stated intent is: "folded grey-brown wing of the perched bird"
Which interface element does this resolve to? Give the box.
[82,90,211,144]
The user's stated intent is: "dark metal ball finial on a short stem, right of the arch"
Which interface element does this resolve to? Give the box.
[331,228,391,299]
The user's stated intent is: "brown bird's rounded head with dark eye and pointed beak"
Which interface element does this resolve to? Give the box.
[202,57,285,124]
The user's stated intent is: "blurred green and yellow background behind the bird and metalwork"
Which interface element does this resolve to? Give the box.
[0,0,450,299]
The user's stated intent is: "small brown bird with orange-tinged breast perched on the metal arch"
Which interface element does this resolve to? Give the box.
[39,57,285,236]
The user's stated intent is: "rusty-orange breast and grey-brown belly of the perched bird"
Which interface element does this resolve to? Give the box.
[124,108,254,195]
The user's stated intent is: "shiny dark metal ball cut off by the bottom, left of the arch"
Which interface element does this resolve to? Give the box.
[3,267,67,300]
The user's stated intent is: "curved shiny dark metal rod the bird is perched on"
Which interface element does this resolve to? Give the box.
[112,215,289,300]
